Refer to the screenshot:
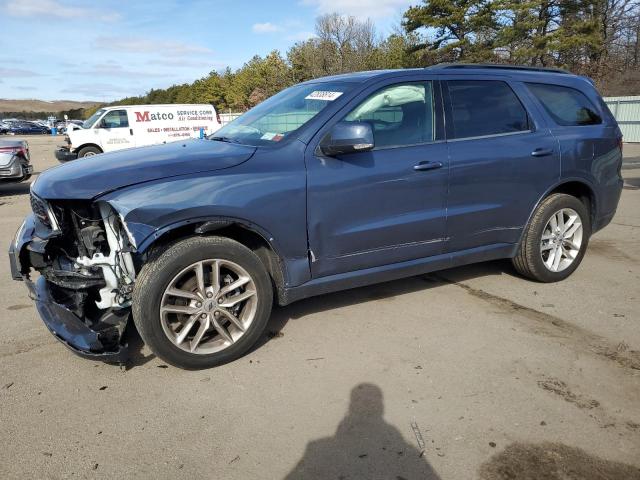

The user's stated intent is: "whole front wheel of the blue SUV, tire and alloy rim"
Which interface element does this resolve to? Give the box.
[132,237,273,370]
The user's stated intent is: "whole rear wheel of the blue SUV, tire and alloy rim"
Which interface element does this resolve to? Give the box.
[512,193,591,283]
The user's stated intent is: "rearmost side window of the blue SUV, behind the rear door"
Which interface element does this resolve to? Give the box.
[527,83,602,126]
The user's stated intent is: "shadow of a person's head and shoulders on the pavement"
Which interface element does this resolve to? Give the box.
[285,383,440,480]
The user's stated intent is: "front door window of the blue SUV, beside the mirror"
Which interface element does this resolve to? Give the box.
[343,82,434,148]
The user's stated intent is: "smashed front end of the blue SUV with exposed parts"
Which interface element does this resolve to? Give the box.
[9,193,136,362]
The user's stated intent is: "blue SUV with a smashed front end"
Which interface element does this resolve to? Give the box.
[10,65,622,368]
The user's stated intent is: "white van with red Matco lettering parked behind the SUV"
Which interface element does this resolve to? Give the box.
[56,104,222,162]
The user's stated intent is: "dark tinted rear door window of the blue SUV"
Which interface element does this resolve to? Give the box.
[447,80,530,138]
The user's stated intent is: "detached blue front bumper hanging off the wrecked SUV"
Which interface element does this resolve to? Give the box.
[9,215,129,363]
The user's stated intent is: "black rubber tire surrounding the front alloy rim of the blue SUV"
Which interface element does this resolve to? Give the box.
[132,237,273,370]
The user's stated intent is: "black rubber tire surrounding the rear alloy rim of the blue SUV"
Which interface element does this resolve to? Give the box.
[512,193,591,283]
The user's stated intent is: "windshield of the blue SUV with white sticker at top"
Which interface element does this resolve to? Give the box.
[208,82,351,146]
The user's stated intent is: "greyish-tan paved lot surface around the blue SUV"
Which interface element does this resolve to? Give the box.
[0,137,640,480]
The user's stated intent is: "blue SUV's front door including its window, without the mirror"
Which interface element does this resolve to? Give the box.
[306,81,448,278]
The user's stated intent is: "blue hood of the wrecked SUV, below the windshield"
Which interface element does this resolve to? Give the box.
[32,140,256,200]
